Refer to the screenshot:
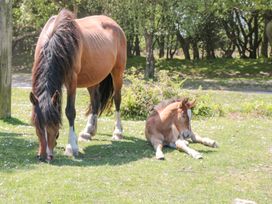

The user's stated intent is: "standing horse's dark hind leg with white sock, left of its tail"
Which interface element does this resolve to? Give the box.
[79,85,101,141]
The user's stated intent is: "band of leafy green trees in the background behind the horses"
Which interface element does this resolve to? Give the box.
[13,0,272,78]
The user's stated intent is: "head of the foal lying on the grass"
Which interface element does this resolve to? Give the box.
[175,98,196,138]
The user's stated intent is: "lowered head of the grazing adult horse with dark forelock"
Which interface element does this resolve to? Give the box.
[30,91,61,161]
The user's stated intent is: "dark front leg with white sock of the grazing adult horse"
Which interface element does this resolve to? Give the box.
[65,80,78,156]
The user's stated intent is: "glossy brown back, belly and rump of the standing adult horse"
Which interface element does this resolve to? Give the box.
[76,15,126,87]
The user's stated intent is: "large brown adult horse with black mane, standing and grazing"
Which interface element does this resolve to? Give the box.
[30,10,127,160]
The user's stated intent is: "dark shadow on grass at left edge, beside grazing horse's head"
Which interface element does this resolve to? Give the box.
[0,132,38,172]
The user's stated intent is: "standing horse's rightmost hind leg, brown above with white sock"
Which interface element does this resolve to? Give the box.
[112,69,123,140]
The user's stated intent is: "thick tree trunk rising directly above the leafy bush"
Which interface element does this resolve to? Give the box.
[145,32,155,79]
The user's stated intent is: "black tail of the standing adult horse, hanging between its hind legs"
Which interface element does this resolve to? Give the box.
[99,74,114,115]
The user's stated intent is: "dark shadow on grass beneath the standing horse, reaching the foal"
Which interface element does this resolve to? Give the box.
[52,135,154,166]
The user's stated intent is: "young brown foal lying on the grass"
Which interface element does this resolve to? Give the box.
[145,98,218,159]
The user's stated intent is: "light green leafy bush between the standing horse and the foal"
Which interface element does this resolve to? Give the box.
[121,70,182,119]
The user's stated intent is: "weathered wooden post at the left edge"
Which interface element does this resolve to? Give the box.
[0,0,12,118]
